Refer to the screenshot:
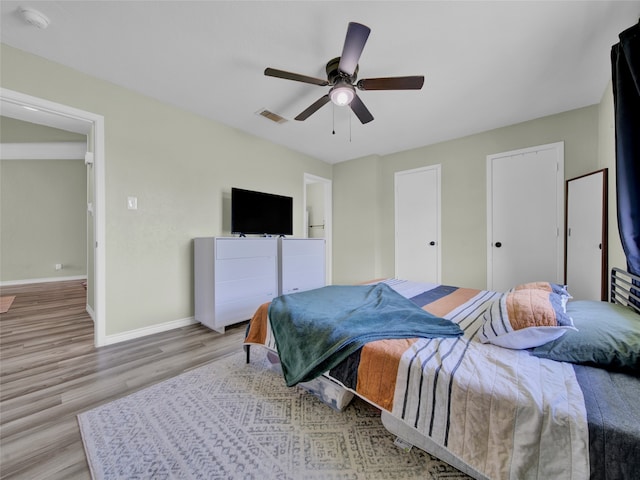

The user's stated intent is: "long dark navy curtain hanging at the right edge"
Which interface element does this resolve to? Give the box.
[611,22,640,275]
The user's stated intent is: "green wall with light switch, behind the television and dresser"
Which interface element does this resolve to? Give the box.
[0,45,332,335]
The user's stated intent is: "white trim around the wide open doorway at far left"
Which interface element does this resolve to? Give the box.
[0,88,106,347]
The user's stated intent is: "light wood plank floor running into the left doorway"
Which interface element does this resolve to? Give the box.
[0,281,245,480]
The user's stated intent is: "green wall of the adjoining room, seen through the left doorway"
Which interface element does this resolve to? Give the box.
[0,117,87,283]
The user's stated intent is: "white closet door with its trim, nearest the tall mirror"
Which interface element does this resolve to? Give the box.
[487,142,564,292]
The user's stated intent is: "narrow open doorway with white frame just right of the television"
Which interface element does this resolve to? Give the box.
[302,173,333,285]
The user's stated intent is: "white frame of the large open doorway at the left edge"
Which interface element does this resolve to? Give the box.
[0,88,106,347]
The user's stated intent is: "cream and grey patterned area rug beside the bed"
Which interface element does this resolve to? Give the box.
[78,348,468,480]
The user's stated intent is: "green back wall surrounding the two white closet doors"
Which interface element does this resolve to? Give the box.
[334,103,617,288]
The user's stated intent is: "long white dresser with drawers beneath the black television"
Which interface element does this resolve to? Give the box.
[194,237,325,333]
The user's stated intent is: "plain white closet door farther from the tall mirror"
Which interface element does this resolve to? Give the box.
[395,165,440,283]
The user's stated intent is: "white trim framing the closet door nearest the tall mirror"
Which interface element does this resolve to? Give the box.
[487,142,564,290]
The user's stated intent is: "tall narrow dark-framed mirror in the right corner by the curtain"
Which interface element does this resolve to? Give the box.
[566,169,607,300]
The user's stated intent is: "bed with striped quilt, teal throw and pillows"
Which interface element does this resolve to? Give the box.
[245,269,640,479]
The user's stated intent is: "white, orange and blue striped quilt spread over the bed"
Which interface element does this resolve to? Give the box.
[246,280,589,480]
